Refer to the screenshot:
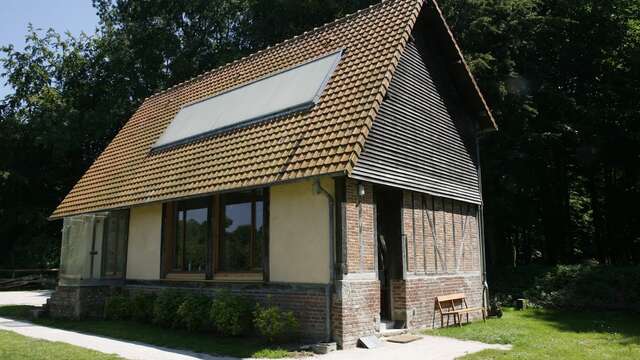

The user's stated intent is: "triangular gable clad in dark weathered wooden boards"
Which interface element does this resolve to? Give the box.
[352,34,481,203]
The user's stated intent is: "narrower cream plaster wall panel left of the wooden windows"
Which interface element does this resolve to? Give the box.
[127,204,162,280]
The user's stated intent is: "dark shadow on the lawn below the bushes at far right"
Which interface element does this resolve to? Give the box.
[523,310,640,345]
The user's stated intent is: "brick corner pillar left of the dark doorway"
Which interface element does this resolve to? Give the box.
[332,179,380,348]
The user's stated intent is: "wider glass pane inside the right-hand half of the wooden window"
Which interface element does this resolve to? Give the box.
[220,198,251,271]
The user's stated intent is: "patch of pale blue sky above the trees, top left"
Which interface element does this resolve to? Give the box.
[0,0,98,98]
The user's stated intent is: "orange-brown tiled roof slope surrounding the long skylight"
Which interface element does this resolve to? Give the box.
[51,0,422,218]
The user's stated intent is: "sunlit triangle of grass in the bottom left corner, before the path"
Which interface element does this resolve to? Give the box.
[0,330,120,360]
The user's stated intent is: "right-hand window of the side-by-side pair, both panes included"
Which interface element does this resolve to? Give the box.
[219,190,265,272]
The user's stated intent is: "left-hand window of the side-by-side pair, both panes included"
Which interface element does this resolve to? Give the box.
[173,199,209,272]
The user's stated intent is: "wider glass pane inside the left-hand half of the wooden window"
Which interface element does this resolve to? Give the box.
[184,208,208,272]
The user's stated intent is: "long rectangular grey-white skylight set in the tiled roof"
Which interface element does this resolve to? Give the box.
[152,50,342,150]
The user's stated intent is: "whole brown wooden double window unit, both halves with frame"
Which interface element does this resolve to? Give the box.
[161,189,268,281]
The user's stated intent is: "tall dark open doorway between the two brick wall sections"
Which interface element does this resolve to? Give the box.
[374,186,402,320]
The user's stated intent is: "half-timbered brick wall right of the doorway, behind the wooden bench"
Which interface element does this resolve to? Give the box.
[392,191,483,329]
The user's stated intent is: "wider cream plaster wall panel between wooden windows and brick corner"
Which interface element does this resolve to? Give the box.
[269,178,334,284]
